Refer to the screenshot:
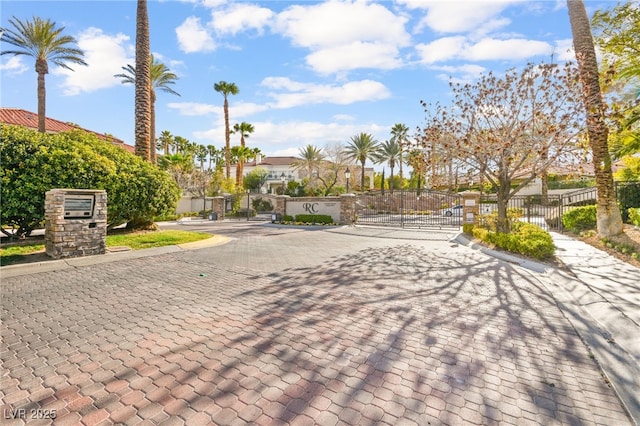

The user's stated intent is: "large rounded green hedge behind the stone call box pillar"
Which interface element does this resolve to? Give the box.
[0,125,180,236]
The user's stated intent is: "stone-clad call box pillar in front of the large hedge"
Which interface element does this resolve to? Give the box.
[44,189,107,259]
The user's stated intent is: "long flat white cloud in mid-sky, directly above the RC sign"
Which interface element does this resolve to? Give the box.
[262,77,390,109]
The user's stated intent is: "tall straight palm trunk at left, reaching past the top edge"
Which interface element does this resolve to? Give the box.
[135,0,151,161]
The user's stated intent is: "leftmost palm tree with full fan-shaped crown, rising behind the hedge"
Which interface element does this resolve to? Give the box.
[0,16,87,133]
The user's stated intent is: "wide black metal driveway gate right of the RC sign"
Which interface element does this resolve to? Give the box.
[356,190,462,228]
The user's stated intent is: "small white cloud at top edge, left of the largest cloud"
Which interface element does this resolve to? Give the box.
[209,3,275,35]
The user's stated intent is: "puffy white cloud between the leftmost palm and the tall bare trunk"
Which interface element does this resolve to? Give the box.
[52,27,135,96]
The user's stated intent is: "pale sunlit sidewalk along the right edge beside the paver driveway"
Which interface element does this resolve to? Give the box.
[546,232,640,424]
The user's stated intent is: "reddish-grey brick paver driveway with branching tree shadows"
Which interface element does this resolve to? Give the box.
[0,224,630,425]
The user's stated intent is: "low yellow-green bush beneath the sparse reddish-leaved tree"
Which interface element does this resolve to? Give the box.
[472,222,555,260]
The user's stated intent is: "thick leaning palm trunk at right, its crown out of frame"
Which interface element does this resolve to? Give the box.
[567,0,624,238]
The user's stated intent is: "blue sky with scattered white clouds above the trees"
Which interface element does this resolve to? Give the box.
[0,0,615,165]
